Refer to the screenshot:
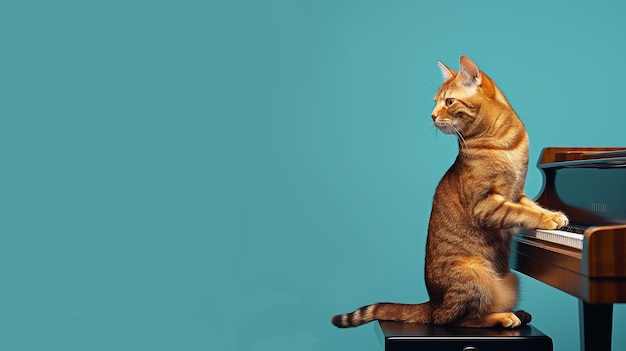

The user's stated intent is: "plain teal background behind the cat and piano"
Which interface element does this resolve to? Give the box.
[0,0,626,351]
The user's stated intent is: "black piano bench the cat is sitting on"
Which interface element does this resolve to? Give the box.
[375,322,552,351]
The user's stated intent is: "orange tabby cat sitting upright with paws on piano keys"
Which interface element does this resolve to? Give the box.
[332,56,568,328]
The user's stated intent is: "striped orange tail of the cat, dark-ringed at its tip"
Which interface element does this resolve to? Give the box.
[332,302,432,328]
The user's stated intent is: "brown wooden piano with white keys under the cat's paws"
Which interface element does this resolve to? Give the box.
[511,147,626,351]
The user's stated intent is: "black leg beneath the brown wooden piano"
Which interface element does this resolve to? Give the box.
[578,300,613,351]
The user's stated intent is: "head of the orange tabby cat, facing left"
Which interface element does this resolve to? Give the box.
[431,56,508,139]
